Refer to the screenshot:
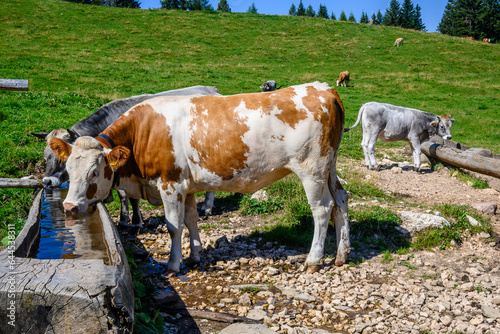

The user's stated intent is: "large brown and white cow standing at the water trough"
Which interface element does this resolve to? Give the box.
[50,82,350,275]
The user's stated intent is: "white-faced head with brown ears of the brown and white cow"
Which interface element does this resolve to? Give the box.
[49,137,130,213]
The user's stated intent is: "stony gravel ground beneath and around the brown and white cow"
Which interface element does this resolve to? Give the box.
[125,153,500,334]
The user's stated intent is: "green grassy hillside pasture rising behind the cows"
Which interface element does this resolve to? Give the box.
[0,0,500,240]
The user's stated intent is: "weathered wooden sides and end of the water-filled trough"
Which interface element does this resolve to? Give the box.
[0,187,134,334]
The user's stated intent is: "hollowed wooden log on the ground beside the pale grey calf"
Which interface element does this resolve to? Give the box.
[422,136,500,178]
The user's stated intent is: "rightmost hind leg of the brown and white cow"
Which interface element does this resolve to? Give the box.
[331,173,351,266]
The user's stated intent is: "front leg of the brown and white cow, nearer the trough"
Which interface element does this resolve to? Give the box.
[163,186,185,277]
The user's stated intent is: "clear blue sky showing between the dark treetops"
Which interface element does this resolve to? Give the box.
[138,0,448,32]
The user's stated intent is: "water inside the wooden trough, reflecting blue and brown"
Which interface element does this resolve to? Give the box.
[28,184,110,264]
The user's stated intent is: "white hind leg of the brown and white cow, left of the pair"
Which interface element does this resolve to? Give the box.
[299,175,334,272]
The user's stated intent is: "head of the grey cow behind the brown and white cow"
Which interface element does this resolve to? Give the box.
[31,129,78,187]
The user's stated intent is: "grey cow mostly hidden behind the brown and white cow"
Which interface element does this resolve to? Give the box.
[31,86,221,225]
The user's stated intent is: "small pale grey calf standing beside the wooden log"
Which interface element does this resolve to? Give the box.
[344,102,455,170]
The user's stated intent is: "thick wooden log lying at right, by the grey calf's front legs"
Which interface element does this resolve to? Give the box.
[422,141,500,178]
